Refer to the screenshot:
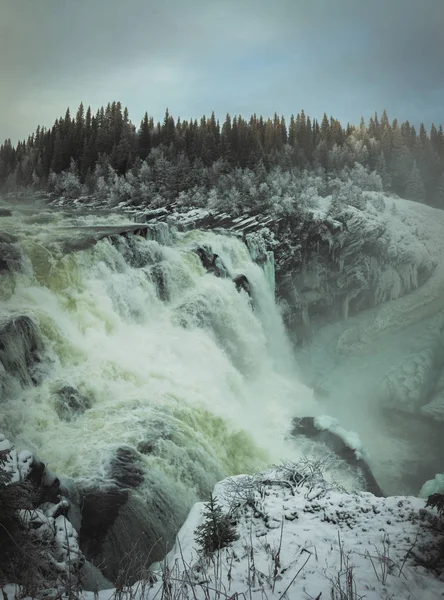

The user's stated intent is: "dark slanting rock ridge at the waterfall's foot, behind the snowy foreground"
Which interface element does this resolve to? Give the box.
[292,417,385,497]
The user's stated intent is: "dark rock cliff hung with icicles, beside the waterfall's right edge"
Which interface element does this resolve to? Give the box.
[274,196,437,341]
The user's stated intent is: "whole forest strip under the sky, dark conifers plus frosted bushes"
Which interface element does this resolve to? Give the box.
[0,102,444,212]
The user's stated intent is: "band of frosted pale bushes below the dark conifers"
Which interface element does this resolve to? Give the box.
[48,156,383,217]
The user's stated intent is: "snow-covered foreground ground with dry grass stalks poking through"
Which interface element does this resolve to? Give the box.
[0,464,444,600]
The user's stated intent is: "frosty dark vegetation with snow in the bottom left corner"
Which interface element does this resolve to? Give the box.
[0,435,84,596]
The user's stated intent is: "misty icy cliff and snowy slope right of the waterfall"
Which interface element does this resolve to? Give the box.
[268,195,444,494]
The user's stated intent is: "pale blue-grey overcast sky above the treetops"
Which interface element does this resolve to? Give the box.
[0,0,444,142]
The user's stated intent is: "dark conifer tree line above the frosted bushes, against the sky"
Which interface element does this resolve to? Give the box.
[0,102,444,208]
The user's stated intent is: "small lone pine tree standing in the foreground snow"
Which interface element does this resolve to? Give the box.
[195,494,239,554]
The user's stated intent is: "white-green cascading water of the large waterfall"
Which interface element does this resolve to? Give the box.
[0,202,316,580]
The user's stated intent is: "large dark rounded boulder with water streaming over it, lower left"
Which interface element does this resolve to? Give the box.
[72,446,188,583]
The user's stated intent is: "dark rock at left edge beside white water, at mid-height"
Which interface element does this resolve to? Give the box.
[0,315,43,391]
